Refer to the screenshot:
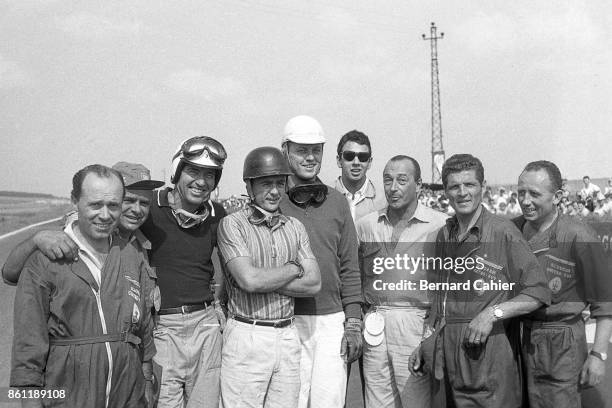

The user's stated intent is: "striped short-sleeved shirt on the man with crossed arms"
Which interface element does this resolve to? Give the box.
[217,207,315,320]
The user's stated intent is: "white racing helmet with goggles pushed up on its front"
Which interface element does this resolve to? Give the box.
[170,136,227,187]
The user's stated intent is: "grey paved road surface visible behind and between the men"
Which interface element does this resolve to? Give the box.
[0,224,612,408]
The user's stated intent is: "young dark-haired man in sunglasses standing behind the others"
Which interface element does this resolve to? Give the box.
[334,130,383,221]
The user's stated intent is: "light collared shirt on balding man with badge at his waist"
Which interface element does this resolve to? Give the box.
[357,203,448,307]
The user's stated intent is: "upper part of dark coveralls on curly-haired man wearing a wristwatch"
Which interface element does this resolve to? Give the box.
[432,210,551,319]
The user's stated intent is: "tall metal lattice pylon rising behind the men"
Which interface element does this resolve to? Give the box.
[422,23,446,184]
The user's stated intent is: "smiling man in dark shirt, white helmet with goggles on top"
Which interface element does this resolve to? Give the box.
[141,136,227,408]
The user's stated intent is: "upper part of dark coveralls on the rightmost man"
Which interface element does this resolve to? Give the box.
[513,214,612,321]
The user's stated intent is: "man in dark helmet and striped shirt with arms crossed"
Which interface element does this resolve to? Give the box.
[218,147,321,408]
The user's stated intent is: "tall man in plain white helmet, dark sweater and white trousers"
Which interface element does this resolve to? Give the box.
[280,116,362,408]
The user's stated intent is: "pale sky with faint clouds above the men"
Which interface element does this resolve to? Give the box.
[0,0,612,196]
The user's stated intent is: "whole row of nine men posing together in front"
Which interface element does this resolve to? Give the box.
[2,116,612,408]
